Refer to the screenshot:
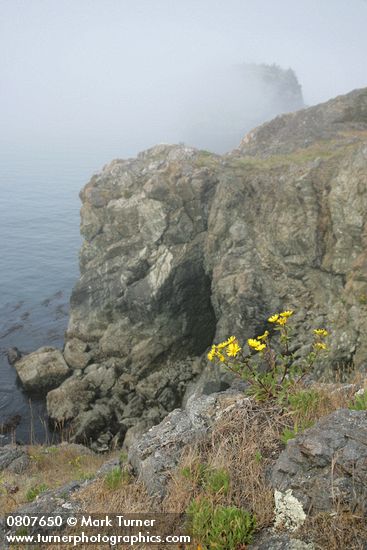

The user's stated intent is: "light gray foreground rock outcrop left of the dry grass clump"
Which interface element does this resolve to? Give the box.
[129,390,248,498]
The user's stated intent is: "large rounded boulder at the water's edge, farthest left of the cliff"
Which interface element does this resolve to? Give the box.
[14,347,70,392]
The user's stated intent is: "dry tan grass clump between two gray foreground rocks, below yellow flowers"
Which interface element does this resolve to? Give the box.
[163,401,284,528]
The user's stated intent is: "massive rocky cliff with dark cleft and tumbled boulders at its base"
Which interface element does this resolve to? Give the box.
[39,89,367,447]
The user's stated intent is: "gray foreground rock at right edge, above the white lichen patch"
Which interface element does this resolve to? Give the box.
[272,409,367,513]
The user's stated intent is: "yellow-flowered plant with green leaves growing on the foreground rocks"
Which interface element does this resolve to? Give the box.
[208,310,328,401]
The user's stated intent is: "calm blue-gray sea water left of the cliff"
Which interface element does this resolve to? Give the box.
[0,147,113,445]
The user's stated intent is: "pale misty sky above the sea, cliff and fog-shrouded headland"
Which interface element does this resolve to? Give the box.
[0,0,367,158]
